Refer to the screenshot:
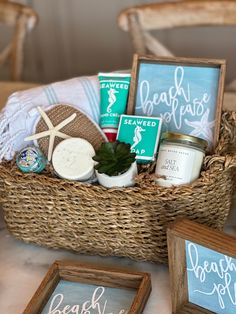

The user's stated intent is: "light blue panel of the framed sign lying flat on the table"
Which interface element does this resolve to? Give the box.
[41,280,137,314]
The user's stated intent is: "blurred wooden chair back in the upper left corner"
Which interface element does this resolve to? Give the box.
[0,0,38,81]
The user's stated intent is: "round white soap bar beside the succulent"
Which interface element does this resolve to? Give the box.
[52,138,95,181]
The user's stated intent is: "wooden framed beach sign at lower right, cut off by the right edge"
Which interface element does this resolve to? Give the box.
[167,219,236,314]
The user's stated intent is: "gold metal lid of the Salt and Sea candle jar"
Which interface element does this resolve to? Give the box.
[161,132,208,151]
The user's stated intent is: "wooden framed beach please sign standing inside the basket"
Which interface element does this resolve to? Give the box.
[127,54,226,151]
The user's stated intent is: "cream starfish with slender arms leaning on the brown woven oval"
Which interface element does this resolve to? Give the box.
[24,107,76,161]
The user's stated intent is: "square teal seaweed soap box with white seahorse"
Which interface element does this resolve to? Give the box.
[117,115,162,163]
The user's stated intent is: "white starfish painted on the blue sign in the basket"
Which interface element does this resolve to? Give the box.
[184,108,215,142]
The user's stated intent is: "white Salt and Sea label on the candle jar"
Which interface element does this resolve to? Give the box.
[156,145,195,185]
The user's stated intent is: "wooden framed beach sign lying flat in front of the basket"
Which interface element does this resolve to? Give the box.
[23,261,151,314]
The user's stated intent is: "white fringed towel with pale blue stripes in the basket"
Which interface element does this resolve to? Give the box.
[0,76,100,161]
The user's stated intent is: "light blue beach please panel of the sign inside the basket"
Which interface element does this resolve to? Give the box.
[135,63,220,147]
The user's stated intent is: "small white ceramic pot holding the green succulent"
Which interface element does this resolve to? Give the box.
[96,161,138,188]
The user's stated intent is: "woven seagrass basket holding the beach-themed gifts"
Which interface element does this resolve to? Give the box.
[0,112,236,262]
